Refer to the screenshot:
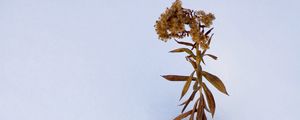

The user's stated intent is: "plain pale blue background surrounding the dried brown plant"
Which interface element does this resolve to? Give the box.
[0,0,300,120]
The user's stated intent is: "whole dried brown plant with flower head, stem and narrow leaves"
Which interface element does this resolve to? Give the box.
[155,0,228,120]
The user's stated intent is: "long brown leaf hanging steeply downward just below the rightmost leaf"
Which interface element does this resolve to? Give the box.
[202,83,216,117]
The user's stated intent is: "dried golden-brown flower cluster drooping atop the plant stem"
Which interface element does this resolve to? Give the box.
[155,0,215,49]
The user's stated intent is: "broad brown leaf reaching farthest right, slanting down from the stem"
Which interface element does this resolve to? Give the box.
[202,71,228,95]
